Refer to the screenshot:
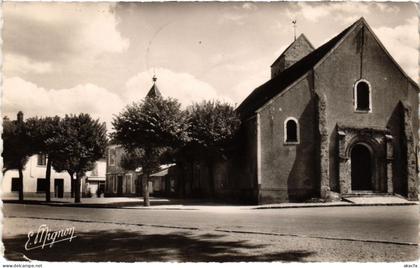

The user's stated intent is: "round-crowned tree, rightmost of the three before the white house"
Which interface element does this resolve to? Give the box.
[54,113,107,203]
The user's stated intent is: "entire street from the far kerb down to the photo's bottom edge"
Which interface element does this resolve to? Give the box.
[3,204,418,262]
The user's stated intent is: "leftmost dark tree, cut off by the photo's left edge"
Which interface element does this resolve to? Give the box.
[1,112,31,201]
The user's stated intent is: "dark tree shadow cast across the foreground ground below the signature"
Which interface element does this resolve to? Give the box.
[3,230,314,262]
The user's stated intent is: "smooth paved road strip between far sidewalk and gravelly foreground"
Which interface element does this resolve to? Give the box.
[3,204,419,244]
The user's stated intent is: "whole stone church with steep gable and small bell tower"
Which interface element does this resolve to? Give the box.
[234,18,419,204]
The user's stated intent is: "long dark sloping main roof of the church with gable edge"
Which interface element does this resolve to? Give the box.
[236,17,418,119]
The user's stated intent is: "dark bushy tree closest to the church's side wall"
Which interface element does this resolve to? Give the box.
[184,101,241,197]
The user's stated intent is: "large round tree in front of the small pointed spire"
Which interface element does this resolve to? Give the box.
[112,96,188,206]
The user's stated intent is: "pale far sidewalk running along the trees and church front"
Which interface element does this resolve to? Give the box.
[3,196,419,212]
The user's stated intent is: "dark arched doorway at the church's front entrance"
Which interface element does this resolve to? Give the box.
[351,144,373,191]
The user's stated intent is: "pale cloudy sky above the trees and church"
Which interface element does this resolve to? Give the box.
[2,2,419,130]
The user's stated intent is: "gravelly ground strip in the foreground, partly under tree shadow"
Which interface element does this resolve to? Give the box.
[3,218,418,262]
